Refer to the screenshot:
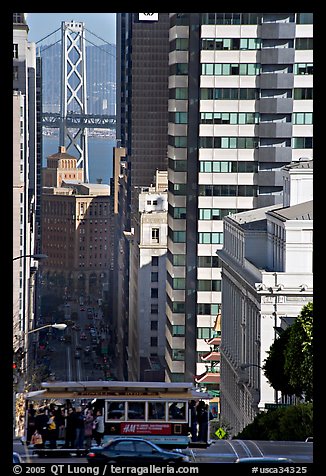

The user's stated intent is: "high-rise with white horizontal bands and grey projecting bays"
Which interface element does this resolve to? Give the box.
[166,13,313,386]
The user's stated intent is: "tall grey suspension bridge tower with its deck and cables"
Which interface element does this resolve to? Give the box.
[36,20,116,182]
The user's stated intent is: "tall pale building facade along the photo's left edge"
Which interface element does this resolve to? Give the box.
[13,13,37,376]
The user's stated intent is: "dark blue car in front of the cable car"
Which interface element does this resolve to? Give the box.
[86,437,190,464]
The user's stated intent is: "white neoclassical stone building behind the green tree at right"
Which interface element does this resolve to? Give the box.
[218,161,313,435]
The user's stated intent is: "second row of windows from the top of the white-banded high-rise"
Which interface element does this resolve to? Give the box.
[200,38,313,51]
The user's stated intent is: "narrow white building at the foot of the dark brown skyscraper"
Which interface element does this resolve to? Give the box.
[125,171,168,380]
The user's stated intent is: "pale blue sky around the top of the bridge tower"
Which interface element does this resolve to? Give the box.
[27,13,116,46]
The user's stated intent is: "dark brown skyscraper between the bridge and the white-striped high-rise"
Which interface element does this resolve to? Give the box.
[113,13,169,378]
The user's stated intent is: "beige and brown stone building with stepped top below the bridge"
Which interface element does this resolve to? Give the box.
[42,147,112,299]
